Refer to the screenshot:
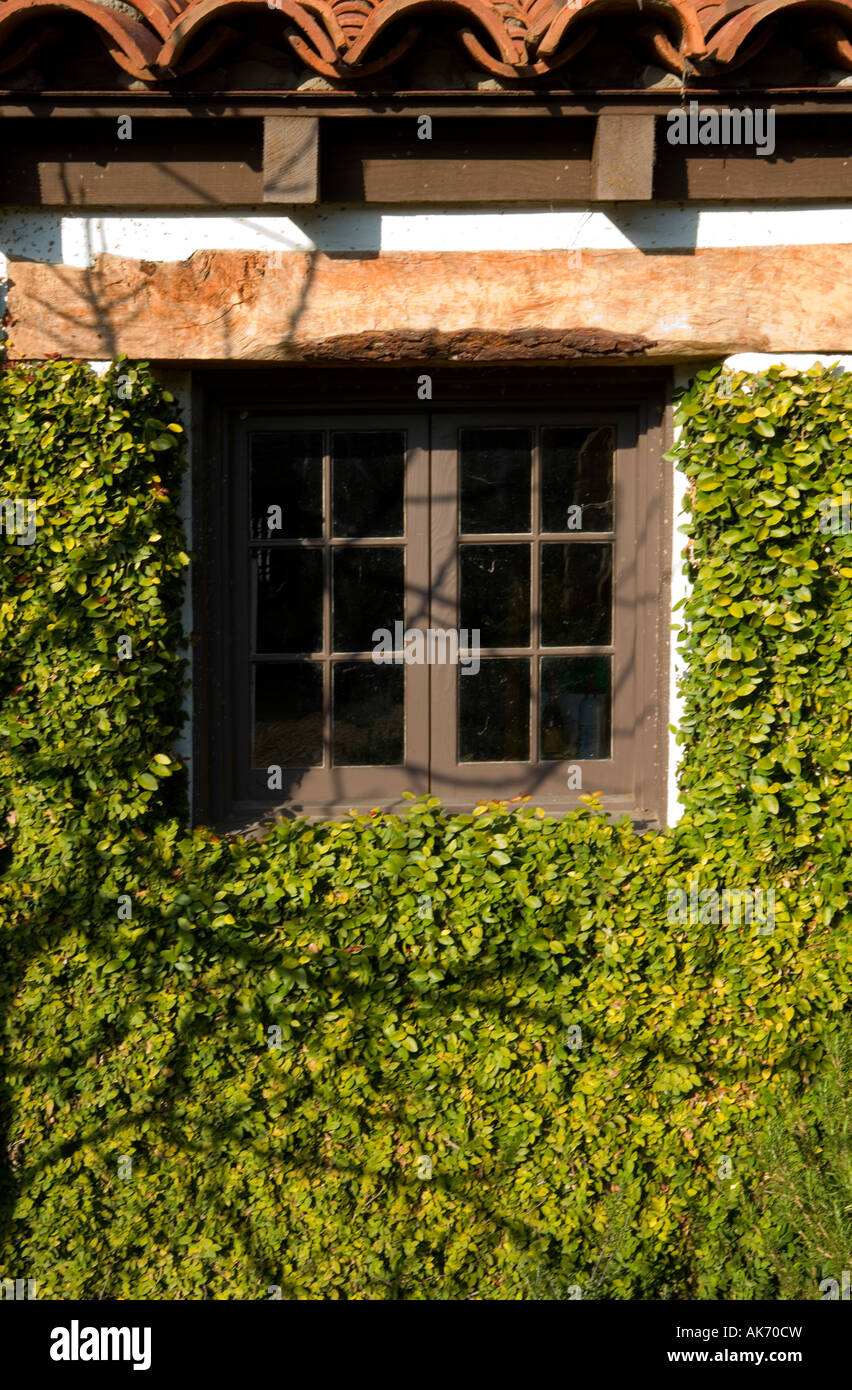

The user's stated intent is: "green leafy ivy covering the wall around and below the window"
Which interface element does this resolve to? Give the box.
[0,361,852,1298]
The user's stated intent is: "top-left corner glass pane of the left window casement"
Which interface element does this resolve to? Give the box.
[250,430,322,541]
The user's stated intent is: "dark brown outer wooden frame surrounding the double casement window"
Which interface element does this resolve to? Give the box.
[192,363,671,830]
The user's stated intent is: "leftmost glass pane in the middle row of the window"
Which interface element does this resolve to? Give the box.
[252,546,322,653]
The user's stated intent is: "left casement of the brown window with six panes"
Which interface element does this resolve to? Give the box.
[235,416,429,806]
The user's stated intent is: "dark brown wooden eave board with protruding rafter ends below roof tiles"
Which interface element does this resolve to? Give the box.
[0,111,852,209]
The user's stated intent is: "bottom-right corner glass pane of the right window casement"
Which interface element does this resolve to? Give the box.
[541,656,612,762]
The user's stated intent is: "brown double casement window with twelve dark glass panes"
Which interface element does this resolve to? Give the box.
[196,369,667,823]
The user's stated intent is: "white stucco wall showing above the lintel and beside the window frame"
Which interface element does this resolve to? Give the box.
[6,202,852,824]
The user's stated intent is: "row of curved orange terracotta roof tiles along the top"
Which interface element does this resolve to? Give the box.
[0,0,852,88]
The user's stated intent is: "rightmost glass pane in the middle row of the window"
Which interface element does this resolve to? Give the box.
[541,541,613,646]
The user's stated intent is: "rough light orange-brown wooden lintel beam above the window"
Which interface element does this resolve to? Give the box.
[7,245,852,361]
